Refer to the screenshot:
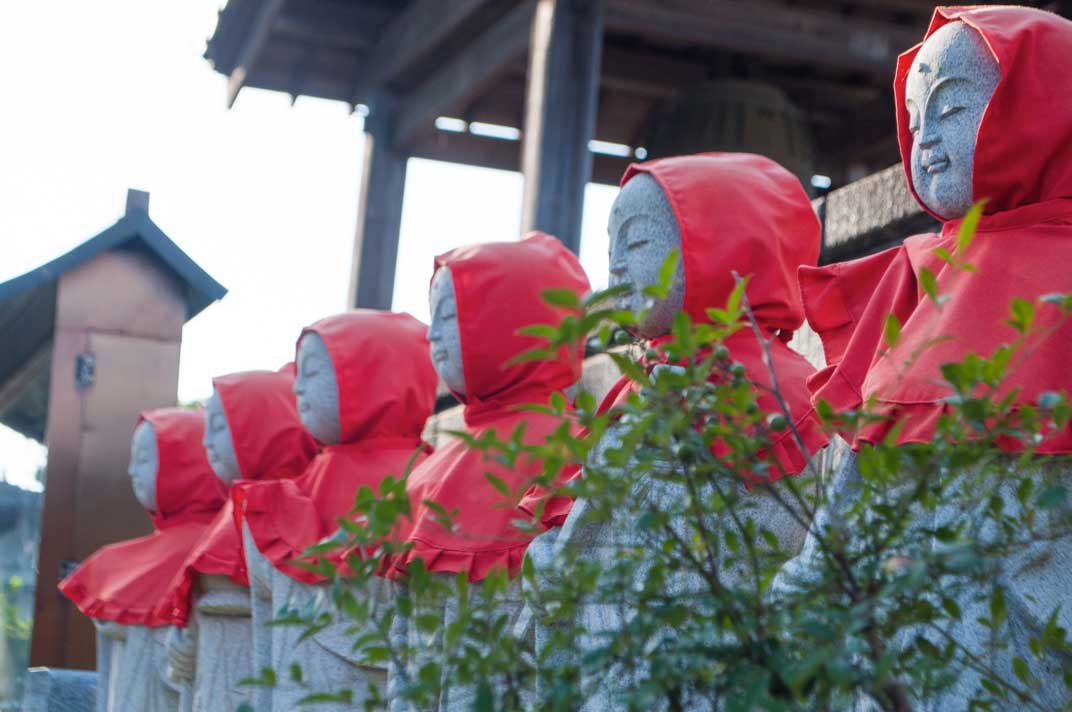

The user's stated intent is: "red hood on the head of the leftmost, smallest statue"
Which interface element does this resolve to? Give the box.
[141,407,224,531]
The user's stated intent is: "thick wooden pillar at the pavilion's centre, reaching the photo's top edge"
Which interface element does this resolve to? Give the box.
[521,0,604,252]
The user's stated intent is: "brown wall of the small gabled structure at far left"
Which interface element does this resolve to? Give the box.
[30,248,187,669]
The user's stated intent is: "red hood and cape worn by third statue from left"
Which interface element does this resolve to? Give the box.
[241,310,436,583]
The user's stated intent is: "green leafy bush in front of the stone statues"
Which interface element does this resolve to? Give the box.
[265,216,1072,712]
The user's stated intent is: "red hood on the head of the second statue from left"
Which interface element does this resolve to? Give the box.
[212,365,316,479]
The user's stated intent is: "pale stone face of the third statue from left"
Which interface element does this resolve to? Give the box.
[294,331,340,445]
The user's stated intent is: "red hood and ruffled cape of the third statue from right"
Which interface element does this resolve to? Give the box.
[386,233,590,581]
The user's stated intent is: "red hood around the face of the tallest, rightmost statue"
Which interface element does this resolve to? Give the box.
[893,6,1072,220]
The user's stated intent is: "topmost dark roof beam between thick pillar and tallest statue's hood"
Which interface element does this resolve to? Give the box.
[606,0,920,78]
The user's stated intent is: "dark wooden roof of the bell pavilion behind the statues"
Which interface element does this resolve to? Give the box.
[205,0,1069,186]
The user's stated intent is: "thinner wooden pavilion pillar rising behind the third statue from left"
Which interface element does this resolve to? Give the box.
[349,94,410,309]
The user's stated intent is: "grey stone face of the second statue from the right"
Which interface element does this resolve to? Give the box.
[607,173,685,339]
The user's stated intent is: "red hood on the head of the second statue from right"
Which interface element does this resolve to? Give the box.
[622,153,820,338]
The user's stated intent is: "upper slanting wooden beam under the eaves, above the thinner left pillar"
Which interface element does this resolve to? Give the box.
[351,0,517,104]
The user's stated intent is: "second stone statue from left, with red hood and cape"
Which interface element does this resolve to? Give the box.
[160,367,315,712]
